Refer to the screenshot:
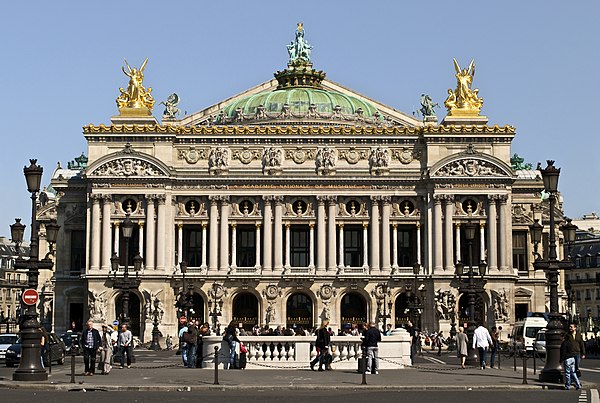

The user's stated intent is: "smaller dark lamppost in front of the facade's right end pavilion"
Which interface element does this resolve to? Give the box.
[455,221,487,365]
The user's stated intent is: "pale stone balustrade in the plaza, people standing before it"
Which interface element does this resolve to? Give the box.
[202,329,410,369]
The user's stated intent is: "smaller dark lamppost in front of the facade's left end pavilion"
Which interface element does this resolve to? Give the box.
[110,214,144,324]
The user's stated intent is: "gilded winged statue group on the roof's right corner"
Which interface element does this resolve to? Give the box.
[444,59,483,116]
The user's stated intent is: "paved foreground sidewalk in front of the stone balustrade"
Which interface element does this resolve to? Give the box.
[0,350,595,391]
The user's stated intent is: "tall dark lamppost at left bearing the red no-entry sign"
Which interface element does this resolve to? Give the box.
[10,159,60,381]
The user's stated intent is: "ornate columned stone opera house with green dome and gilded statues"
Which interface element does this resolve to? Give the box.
[52,27,568,340]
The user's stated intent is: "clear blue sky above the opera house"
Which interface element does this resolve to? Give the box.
[0,0,600,235]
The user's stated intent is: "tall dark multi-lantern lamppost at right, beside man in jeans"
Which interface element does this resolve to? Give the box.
[529,160,577,383]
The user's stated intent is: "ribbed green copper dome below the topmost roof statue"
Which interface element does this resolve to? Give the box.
[225,88,377,118]
